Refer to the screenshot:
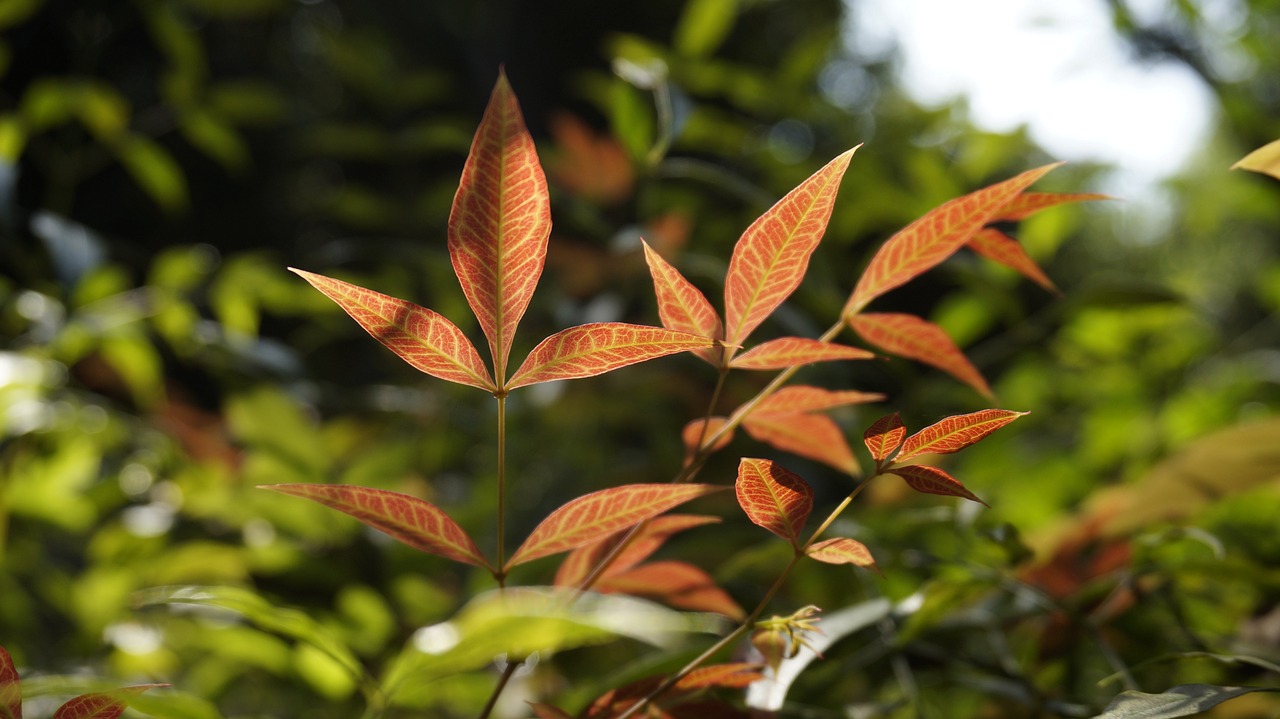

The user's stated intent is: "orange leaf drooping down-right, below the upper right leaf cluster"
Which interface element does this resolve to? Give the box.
[849,313,995,398]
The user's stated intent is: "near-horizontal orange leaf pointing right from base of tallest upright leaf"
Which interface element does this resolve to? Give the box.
[506,322,716,389]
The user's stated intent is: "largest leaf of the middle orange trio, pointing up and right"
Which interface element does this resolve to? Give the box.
[724,147,856,345]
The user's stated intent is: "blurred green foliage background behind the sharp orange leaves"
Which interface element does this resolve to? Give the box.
[0,0,1280,718]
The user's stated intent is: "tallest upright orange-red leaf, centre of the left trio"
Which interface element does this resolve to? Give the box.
[448,73,552,383]
